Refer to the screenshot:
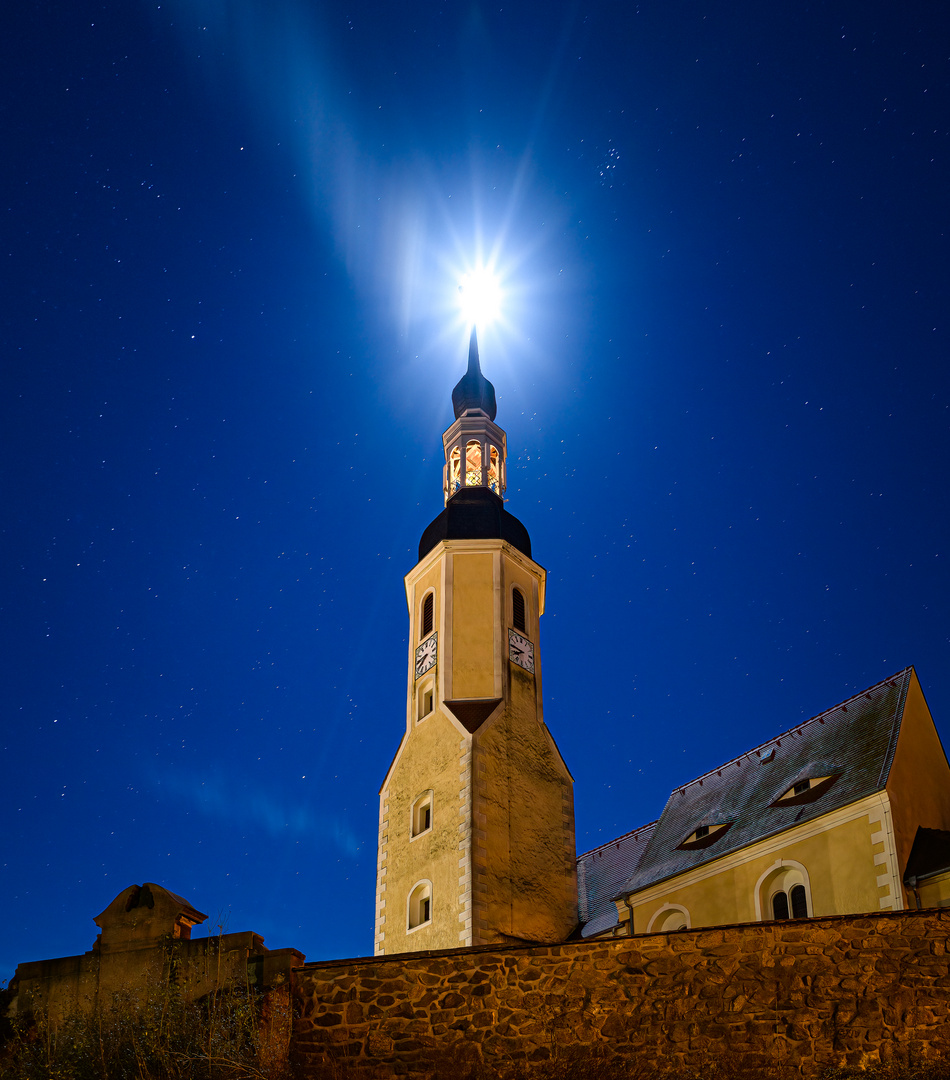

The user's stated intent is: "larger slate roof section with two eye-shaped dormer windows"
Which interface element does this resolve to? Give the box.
[616,667,913,895]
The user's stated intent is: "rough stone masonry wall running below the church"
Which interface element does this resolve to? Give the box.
[294,910,950,1080]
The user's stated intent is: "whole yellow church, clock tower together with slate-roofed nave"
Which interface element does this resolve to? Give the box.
[375,330,950,955]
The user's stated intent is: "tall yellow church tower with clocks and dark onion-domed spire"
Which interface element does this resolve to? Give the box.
[376,329,578,954]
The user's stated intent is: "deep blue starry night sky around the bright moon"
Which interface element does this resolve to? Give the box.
[0,0,950,978]
